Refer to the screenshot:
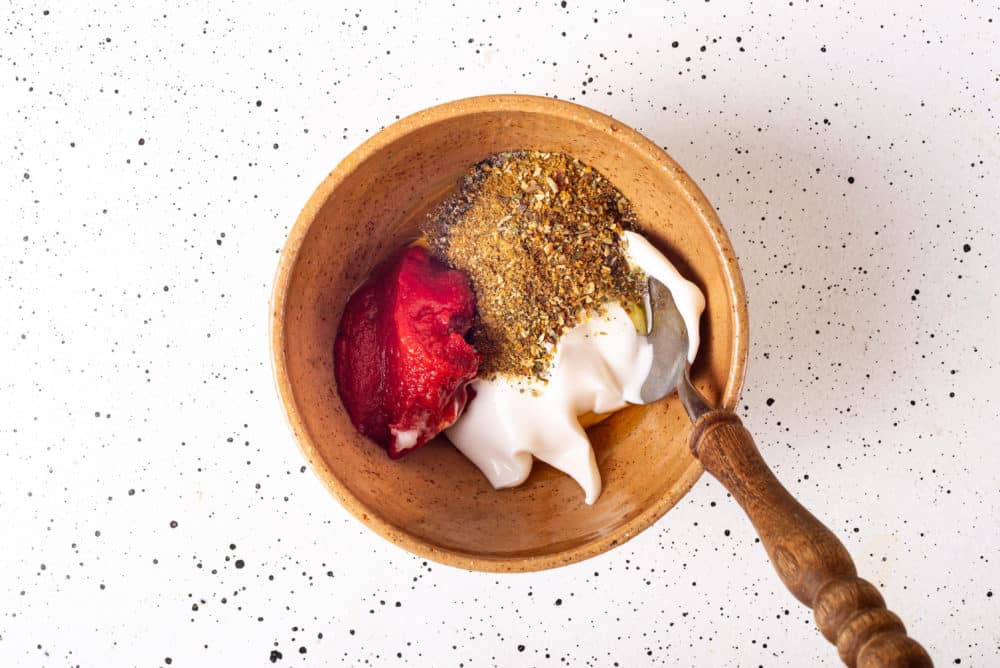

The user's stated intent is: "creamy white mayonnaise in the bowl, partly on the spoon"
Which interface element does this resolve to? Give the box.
[445,232,705,504]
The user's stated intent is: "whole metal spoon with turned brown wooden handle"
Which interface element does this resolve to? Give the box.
[639,278,933,668]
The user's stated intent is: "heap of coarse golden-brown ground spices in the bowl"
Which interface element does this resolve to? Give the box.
[423,151,645,380]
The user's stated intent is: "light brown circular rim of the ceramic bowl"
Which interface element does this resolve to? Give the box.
[269,94,749,573]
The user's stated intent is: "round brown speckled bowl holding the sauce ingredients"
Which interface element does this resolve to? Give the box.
[271,95,747,571]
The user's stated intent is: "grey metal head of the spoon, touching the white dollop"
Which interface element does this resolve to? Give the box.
[639,277,688,404]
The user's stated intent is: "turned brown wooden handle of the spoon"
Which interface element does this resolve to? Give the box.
[691,411,933,668]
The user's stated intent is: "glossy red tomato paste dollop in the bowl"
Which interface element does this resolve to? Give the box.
[334,246,480,459]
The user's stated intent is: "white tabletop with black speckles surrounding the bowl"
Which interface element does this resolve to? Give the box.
[0,0,1000,667]
